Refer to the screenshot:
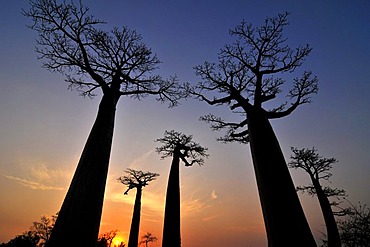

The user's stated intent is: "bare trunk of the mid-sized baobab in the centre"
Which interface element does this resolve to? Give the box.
[162,150,181,247]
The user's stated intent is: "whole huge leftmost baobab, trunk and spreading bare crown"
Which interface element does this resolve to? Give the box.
[23,0,181,247]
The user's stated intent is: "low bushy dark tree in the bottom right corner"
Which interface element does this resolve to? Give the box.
[338,201,370,247]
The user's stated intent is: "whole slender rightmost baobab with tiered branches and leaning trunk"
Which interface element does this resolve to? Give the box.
[288,148,346,247]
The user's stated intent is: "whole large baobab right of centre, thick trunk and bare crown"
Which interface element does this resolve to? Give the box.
[187,13,318,246]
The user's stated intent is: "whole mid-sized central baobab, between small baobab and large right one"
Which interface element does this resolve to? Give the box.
[156,130,208,247]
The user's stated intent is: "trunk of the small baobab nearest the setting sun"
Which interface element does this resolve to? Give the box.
[128,186,142,247]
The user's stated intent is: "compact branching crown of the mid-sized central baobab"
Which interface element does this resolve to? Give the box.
[156,130,209,166]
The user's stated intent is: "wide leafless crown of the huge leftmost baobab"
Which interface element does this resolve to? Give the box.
[23,0,184,106]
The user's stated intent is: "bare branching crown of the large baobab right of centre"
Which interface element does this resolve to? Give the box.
[186,12,318,143]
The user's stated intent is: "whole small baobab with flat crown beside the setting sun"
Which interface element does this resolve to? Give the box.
[118,168,159,247]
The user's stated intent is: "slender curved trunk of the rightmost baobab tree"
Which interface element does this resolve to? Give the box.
[311,177,341,247]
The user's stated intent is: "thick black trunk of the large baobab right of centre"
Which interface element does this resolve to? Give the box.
[248,109,316,247]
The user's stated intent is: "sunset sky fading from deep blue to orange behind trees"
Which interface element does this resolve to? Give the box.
[0,0,370,247]
